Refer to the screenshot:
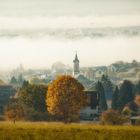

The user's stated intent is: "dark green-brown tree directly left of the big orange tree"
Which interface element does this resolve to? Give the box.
[18,82,47,120]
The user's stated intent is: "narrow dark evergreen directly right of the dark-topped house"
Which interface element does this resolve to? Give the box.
[96,81,107,111]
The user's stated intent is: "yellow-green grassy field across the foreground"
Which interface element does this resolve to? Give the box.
[0,122,140,140]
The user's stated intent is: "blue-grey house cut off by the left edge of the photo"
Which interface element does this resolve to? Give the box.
[0,85,16,115]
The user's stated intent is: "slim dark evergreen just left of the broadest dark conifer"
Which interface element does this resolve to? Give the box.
[111,86,119,109]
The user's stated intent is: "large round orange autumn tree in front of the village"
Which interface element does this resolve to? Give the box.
[46,75,87,122]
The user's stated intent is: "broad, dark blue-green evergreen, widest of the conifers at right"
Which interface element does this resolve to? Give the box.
[118,80,134,110]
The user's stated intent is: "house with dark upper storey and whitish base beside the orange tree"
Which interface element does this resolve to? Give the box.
[80,91,99,120]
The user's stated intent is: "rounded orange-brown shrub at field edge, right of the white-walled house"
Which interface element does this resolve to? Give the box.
[101,109,128,125]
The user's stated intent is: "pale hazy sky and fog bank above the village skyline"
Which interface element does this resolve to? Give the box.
[0,0,140,69]
